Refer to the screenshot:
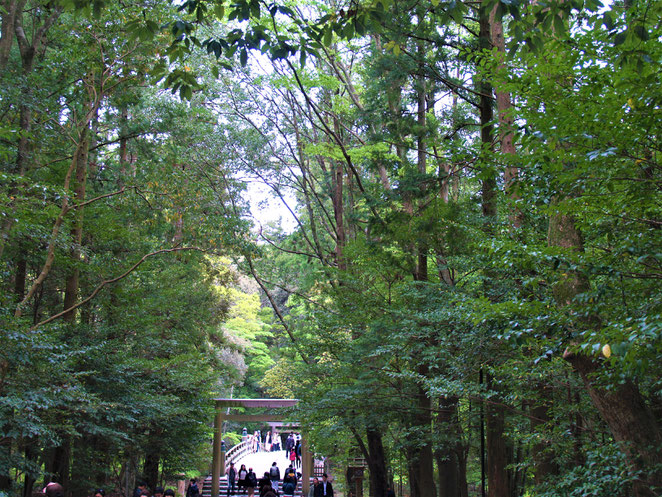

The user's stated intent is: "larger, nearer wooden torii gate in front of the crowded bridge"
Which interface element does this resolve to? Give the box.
[211,399,313,497]
